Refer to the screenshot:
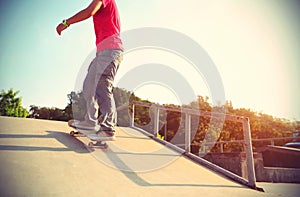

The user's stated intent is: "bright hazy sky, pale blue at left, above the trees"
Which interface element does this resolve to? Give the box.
[0,0,300,120]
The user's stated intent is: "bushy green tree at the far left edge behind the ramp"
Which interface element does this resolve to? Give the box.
[0,89,29,117]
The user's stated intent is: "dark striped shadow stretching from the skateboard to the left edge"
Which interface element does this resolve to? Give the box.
[0,131,89,153]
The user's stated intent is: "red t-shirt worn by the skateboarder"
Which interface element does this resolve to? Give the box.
[93,0,123,52]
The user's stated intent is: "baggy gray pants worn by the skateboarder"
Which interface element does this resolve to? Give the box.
[83,50,123,131]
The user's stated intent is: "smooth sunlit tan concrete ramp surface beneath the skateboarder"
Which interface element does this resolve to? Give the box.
[0,117,300,197]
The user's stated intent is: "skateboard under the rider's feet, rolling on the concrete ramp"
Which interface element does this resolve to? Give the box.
[68,121,108,149]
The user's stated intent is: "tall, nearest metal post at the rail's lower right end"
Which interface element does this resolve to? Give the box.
[243,118,256,188]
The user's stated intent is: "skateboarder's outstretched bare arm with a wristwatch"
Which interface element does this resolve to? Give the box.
[56,0,102,35]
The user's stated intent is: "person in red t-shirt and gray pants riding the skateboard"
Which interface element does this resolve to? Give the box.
[56,0,123,140]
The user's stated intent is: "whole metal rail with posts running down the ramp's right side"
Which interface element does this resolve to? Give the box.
[130,102,256,189]
